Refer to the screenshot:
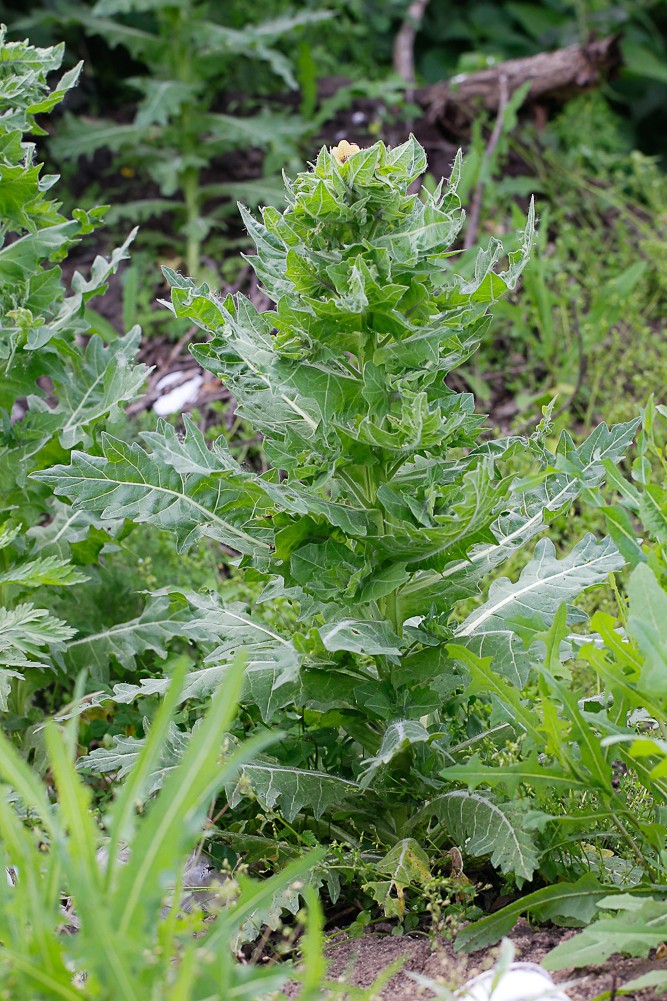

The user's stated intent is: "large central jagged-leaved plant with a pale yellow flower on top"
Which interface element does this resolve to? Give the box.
[39,137,635,880]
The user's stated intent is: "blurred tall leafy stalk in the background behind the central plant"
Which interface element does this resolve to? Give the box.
[51,0,331,275]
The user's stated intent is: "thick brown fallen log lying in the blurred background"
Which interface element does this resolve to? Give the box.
[415,34,622,121]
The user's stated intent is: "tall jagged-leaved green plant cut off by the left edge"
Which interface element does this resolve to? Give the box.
[0,31,286,767]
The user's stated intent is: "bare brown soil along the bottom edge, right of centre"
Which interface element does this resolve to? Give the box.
[287,920,667,1001]
